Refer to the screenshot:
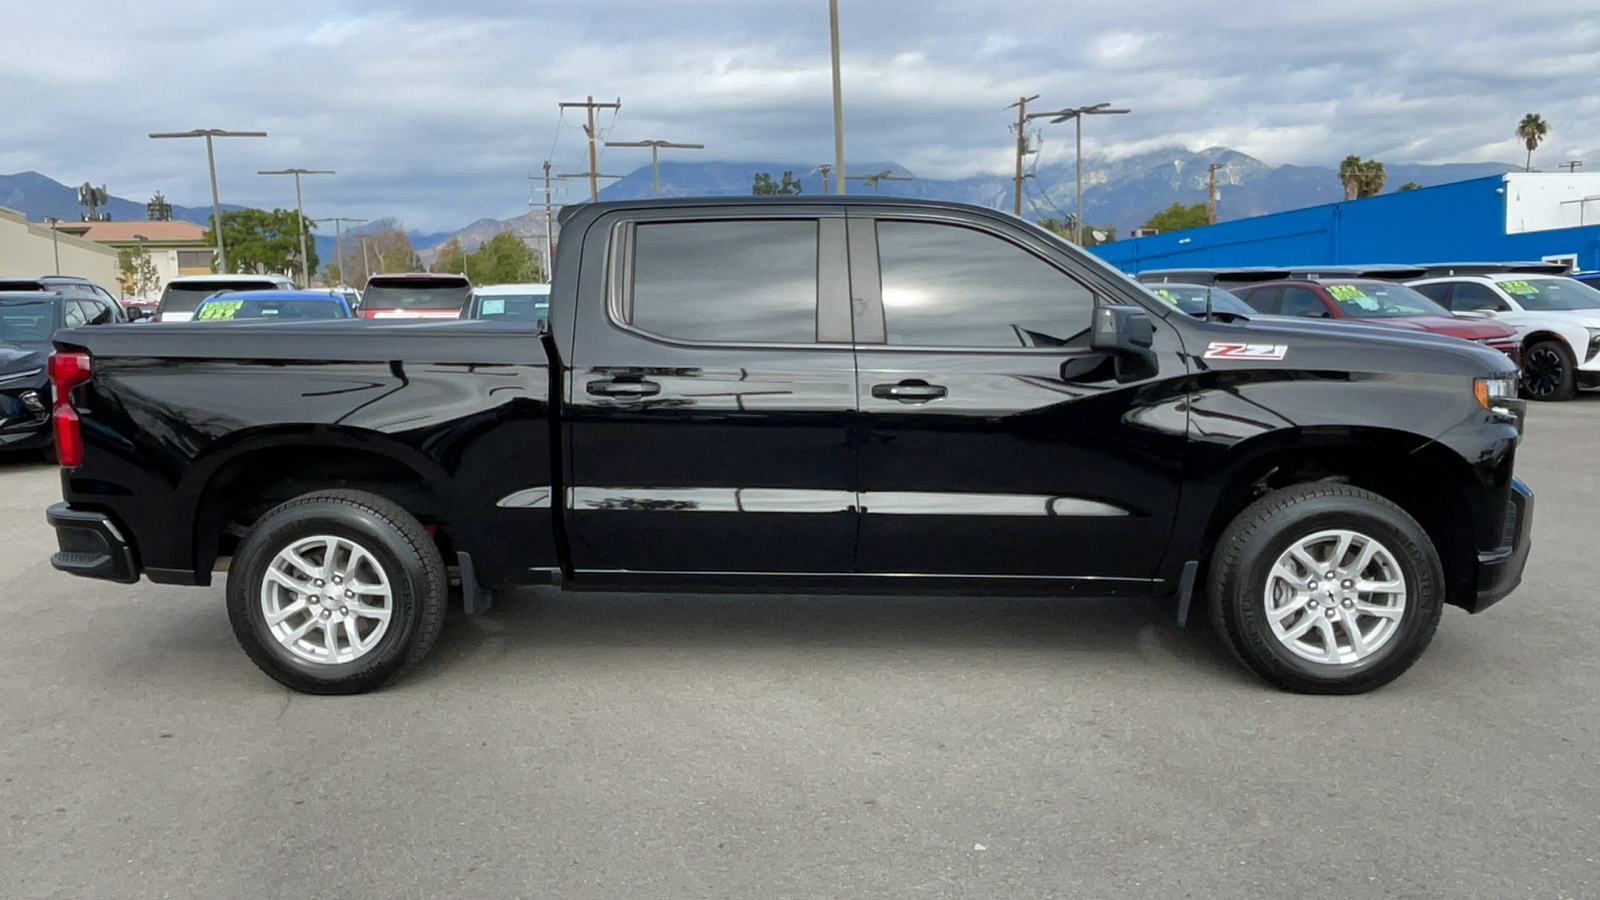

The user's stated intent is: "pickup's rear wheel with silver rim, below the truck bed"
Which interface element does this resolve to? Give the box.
[227,490,448,693]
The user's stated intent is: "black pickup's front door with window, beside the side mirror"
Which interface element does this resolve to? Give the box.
[850,210,1187,594]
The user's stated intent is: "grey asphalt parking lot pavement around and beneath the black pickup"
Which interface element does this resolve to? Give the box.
[0,392,1600,900]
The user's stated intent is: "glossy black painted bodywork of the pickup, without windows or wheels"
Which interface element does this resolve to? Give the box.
[46,197,1531,609]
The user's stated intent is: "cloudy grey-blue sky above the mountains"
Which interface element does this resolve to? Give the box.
[0,0,1600,231]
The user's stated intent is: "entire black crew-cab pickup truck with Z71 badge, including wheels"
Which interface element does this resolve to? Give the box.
[48,197,1533,693]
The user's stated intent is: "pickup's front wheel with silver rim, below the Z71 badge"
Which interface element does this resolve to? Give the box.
[1210,482,1445,693]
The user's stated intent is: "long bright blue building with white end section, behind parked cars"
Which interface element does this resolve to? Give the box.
[1091,171,1600,272]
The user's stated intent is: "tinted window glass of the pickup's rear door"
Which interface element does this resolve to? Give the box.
[624,219,818,344]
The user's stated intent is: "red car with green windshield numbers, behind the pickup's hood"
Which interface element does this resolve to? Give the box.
[1229,279,1522,368]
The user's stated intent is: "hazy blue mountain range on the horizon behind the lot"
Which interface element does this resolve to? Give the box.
[0,147,1518,261]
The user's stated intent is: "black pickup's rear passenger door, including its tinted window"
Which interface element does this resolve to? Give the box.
[565,205,856,583]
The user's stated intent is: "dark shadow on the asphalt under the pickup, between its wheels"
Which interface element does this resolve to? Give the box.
[406,589,1256,684]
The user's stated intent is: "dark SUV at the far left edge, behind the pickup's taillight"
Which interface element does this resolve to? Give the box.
[0,290,126,450]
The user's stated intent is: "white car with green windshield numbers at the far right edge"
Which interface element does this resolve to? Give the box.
[1411,272,1600,400]
